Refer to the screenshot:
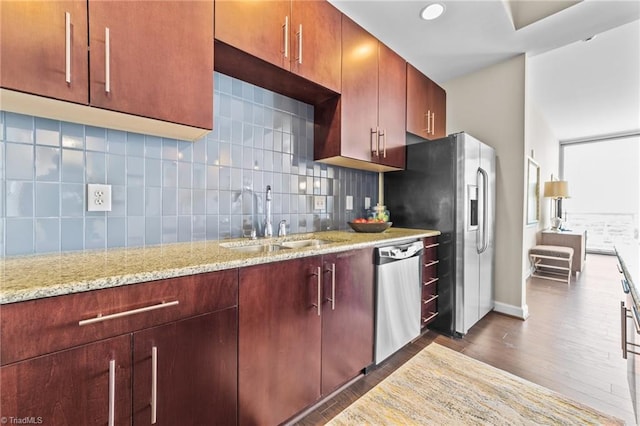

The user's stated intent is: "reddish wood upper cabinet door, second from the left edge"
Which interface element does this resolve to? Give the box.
[89,0,213,129]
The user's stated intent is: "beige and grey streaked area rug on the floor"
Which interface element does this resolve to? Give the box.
[328,343,624,426]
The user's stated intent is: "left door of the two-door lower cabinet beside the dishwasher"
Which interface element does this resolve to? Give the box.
[238,256,321,425]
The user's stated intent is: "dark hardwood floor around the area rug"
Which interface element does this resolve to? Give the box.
[295,254,635,425]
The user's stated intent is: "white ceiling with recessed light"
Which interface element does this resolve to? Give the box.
[329,0,640,140]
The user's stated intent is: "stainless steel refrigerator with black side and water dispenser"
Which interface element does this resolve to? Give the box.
[384,133,496,336]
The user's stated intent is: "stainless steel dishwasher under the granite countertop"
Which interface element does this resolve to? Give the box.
[375,241,423,364]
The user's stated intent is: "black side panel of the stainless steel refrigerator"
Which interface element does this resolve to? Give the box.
[384,137,457,336]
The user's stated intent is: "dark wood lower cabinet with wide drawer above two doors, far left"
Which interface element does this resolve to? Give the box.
[0,270,238,426]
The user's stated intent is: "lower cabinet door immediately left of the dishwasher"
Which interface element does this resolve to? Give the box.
[322,248,374,395]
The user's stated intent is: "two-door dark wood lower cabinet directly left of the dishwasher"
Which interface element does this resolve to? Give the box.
[238,248,374,425]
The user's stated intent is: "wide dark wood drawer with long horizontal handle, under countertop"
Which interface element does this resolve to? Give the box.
[0,269,238,365]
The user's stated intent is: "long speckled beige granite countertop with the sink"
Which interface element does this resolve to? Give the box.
[0,227,440,304]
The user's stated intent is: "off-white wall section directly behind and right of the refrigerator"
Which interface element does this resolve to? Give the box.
[443,55,528,318]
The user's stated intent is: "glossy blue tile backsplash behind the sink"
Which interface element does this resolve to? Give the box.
[0,73,378,256]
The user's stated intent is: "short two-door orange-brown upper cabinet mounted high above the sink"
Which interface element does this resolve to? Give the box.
[215,0,341,97]
